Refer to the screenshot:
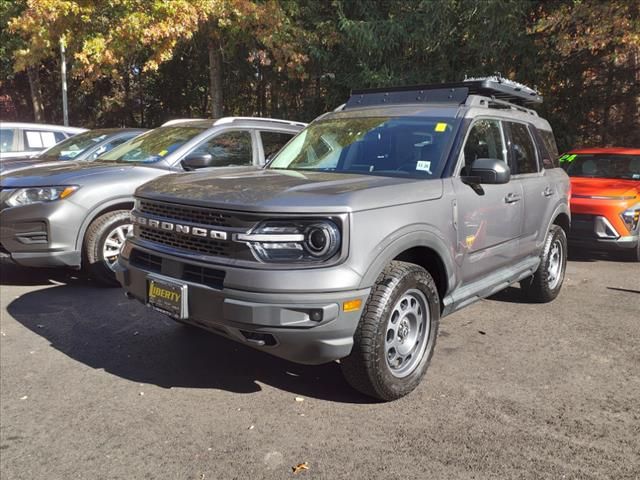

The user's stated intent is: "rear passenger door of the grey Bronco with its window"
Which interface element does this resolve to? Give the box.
[504,121,555,258]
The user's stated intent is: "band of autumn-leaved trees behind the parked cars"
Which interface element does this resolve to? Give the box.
[0,0,640,148]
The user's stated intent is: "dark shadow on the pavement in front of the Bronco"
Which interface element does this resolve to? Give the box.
[3,269,372,403]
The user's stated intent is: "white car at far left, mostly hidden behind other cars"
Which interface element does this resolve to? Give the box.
[0,122,87,158]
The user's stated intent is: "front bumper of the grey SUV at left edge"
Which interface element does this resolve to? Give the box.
[0,201,84,267]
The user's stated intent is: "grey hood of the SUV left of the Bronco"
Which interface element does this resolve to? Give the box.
[0,161,168,188]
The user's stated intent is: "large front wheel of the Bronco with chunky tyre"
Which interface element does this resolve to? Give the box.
[340,261,440,401]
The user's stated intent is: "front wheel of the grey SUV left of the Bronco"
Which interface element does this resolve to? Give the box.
[84,210,133,287]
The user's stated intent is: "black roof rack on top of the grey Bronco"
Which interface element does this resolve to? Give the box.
[344,77,542,109]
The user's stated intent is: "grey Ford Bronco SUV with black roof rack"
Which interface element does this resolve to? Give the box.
[116,78,570,400]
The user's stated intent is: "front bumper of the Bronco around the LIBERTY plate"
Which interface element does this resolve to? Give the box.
[116,248,370,365]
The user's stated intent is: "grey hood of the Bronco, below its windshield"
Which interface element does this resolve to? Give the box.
[136,169,443,213]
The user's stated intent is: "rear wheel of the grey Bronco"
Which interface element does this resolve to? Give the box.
[520,225,567,303]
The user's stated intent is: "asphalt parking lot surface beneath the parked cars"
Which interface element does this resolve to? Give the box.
[0,256,640,480]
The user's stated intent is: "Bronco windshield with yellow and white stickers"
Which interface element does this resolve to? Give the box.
[268,117,458,178]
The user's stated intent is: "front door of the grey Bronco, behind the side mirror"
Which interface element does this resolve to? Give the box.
[453,118,524,284]
